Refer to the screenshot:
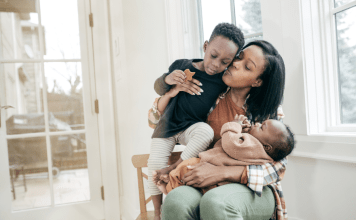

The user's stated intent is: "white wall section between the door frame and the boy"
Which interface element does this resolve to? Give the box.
[109,0,168,220]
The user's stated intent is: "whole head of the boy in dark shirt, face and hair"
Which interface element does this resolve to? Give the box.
[203,23,245,75]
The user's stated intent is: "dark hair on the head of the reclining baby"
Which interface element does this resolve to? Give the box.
[269,125,295,161]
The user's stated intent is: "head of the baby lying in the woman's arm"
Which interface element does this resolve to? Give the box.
[249,119,295,161]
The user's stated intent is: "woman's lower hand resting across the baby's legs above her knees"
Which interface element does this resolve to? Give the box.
[183,162,226,188]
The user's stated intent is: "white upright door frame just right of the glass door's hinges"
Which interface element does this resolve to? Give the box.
[87,0,120,220]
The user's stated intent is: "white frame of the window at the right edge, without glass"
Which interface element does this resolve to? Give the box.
[301,0,356,135]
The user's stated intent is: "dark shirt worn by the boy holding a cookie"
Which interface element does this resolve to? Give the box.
[152,59,227,138]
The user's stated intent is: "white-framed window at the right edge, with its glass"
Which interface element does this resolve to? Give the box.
[301,0,356,135]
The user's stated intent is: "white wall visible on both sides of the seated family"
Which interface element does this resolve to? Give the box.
[105,0,356,219]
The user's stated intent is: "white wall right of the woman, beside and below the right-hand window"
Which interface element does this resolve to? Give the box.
[261,0,356,220]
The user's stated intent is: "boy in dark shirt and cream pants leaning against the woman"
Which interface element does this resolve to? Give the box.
[147,23,244,219]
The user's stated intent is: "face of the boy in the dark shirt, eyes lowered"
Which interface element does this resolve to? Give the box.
[204,36,238,75]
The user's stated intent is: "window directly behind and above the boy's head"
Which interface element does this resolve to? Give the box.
[198,0,263,54]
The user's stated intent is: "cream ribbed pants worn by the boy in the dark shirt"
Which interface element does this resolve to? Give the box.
[147,122,214,195]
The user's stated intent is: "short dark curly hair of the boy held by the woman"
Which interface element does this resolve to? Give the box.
[209,23,245,54]
